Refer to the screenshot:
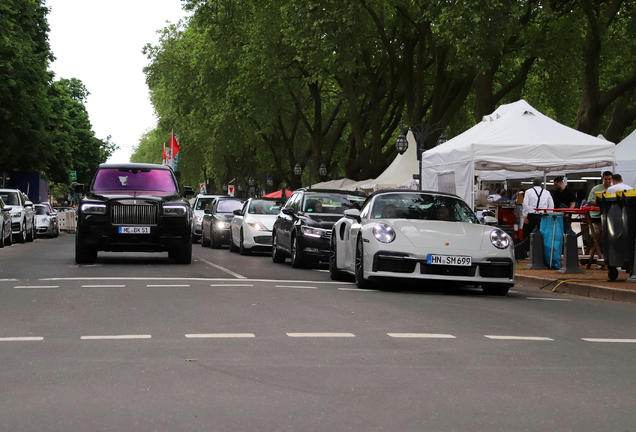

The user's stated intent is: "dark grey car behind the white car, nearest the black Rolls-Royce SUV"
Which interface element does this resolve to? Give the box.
[201,197,246,248]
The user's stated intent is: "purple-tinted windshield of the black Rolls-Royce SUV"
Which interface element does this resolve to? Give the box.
[93,168,177,194]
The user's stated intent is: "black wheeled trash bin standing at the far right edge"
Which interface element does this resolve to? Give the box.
[596,191,636,280]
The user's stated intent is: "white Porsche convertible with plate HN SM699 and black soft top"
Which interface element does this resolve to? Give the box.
[329,190,515,295]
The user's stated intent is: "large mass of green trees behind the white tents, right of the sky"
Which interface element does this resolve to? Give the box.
[142,0,636,188]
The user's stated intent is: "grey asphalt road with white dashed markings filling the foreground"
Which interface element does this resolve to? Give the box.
[0,234,636,431]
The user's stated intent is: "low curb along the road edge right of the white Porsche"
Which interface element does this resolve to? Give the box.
[515,275,636,304]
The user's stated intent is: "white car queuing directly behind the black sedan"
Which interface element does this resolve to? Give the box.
[230,198,285,255]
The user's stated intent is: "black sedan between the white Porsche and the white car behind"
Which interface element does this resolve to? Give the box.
[272,188,367,267]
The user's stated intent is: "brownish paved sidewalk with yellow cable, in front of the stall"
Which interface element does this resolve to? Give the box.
[515,260,636,304]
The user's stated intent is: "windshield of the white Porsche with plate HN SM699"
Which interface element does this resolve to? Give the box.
[371,193,479,224]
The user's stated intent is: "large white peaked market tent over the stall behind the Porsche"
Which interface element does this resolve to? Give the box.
[422,100,616,207]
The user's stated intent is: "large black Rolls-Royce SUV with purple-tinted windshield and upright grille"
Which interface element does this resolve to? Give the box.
[75,163,194,264]
